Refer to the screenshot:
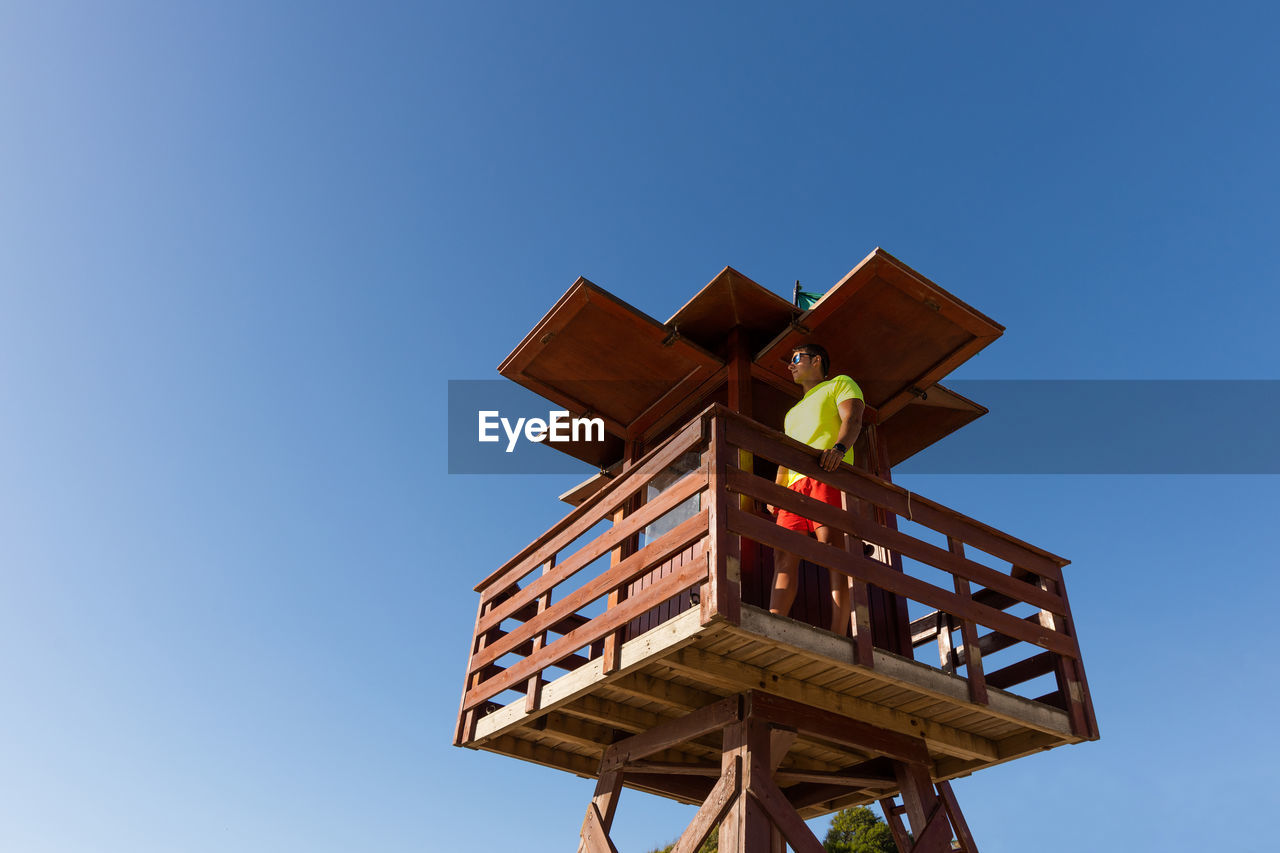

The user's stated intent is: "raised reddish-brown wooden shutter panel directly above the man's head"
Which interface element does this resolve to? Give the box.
[755,248,1005,423]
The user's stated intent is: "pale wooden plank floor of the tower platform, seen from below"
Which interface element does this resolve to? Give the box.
[465,606,1080,818]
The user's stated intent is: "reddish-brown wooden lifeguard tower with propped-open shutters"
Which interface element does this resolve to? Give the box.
[454,250,1098,853]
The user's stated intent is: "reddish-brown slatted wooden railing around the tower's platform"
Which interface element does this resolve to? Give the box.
[456,406,1097,743]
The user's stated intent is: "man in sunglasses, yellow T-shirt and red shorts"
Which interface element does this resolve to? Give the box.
[769,343,864,635]
